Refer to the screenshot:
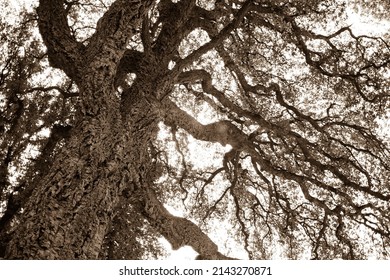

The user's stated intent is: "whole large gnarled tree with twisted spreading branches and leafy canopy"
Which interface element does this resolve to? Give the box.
[0,0,390,259]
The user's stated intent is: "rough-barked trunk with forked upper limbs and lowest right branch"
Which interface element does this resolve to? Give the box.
[6,0,235,259]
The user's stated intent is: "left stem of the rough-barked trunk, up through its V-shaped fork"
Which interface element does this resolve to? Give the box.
[6,0,153,259]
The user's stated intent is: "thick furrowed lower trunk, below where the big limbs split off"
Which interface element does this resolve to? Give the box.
[6,82,157,259]
